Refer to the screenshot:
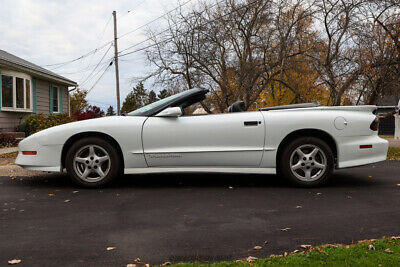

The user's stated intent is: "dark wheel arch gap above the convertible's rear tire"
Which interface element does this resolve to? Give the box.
[276,129,338,164]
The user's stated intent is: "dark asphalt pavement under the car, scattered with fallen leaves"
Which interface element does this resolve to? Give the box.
[0,162,400,266]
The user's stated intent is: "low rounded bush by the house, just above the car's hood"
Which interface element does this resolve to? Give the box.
[24,113,74,136]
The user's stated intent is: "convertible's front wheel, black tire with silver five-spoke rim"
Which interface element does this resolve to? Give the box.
[66,137,121,187]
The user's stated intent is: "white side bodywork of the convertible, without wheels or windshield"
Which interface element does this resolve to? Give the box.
[16,106,388,176]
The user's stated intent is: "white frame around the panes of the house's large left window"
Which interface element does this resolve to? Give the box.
[0,70,33,113]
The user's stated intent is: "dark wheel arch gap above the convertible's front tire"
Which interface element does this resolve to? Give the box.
[61,132,124,170]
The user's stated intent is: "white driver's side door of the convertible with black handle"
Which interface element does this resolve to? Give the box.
[142,111,265,167]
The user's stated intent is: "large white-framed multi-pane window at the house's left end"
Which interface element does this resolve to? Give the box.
[1,71,32,112]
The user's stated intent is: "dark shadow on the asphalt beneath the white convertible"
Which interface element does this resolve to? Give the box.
[14,170,385,190]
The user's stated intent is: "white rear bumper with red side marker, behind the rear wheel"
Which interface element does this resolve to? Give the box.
[337,135,389,168]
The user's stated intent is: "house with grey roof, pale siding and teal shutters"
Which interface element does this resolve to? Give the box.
[0,50,77,132]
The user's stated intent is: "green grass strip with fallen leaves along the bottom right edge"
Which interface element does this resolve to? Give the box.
[172,237,400,267]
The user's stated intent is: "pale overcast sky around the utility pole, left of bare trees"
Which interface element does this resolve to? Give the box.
[0,0,195,109]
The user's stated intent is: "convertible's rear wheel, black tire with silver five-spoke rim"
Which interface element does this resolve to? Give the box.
[278,137,335,187]
